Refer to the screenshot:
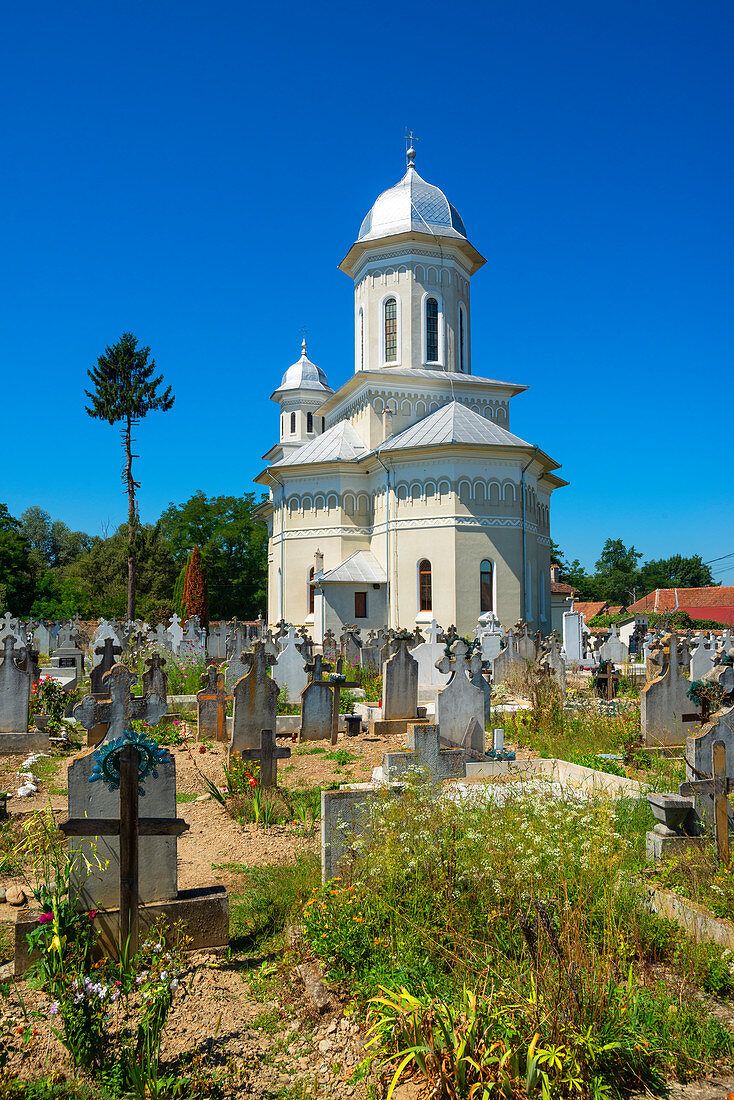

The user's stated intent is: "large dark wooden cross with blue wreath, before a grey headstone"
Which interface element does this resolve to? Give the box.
[58,745,188,957]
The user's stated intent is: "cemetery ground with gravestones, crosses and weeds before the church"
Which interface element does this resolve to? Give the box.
[0,606,734,1098]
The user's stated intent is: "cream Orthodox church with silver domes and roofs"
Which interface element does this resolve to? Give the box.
[255,147,568,641]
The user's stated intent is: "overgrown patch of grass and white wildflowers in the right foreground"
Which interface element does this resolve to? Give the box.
[304,781,734,1100]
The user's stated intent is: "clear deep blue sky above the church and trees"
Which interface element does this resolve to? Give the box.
[0,0,734,583]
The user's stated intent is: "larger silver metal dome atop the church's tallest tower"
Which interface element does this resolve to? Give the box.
[358,163,467,241]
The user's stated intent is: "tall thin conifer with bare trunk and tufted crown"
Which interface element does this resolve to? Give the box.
[85,332,175,619]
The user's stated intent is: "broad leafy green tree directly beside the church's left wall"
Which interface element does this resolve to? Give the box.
[161,490,267,619]
